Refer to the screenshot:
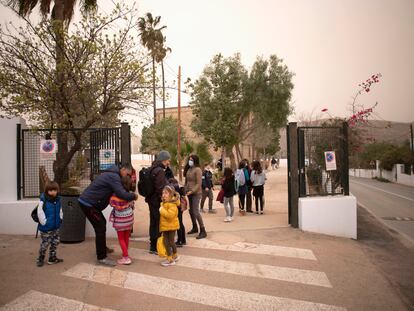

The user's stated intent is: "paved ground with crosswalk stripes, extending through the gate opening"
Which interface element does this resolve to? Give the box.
[0,170,412,311]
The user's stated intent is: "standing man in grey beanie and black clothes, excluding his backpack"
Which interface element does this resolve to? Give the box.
[145,150,171,254]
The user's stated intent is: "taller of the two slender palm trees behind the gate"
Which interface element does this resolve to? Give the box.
[138,13,167,124]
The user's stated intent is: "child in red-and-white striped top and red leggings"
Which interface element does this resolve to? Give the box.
[109,175,134,265]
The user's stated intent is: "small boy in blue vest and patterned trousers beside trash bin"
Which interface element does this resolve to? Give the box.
[36,181,63,267]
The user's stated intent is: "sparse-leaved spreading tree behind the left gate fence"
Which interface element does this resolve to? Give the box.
[0,9,147,183]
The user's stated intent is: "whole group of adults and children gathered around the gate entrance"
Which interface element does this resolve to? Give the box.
[37,150,266,267]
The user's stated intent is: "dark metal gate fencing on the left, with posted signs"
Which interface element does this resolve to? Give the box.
[17,123,131,199]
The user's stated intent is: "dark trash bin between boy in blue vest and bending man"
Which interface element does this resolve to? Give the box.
[60,195,86,243]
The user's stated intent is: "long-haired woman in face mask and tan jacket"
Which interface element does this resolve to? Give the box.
[184,154,207,239]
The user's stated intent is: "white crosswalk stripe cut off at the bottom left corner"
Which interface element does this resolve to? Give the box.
[0,290,114,311]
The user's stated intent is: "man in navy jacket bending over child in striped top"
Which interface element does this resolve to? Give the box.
[79,163,138,266]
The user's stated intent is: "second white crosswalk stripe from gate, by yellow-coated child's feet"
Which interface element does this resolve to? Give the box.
[114,246,332,287]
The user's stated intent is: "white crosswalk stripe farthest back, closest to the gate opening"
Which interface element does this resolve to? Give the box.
[131,238,317,260]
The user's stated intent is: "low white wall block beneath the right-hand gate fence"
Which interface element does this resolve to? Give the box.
[299,195,357,239]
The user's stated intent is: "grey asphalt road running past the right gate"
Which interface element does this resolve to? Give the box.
[350,177,414,242]
